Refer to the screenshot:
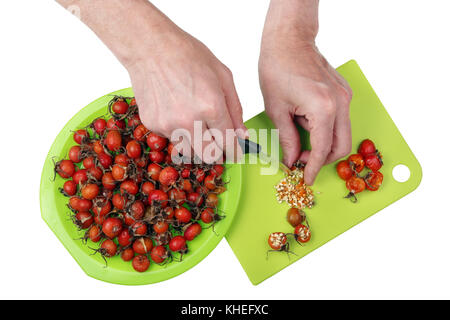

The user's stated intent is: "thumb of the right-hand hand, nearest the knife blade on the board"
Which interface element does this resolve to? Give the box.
[271,108,301,167]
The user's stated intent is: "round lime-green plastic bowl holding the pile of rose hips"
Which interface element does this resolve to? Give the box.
[40,88,242,285]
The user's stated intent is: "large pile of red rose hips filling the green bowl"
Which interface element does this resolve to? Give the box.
[55,96,225,272]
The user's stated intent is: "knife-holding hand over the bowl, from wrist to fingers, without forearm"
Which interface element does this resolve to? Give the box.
[127,25,247,163]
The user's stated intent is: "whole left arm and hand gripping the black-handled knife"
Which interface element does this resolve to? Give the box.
[58,0,247,162]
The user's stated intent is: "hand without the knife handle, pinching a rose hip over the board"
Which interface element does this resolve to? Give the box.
[259,0,352,185]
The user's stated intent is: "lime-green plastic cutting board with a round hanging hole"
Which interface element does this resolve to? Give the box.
[226,60,422,285]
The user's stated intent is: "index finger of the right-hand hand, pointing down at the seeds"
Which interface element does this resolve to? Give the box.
[305,106,335,185]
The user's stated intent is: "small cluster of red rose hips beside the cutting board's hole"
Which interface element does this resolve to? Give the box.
[336,139,383,203]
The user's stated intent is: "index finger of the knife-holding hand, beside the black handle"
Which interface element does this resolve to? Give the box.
[222,69,248,139]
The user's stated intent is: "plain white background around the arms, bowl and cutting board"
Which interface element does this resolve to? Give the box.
[0,0,450,299]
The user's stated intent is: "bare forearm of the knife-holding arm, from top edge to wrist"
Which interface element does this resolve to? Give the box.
[57,0,181,68]
